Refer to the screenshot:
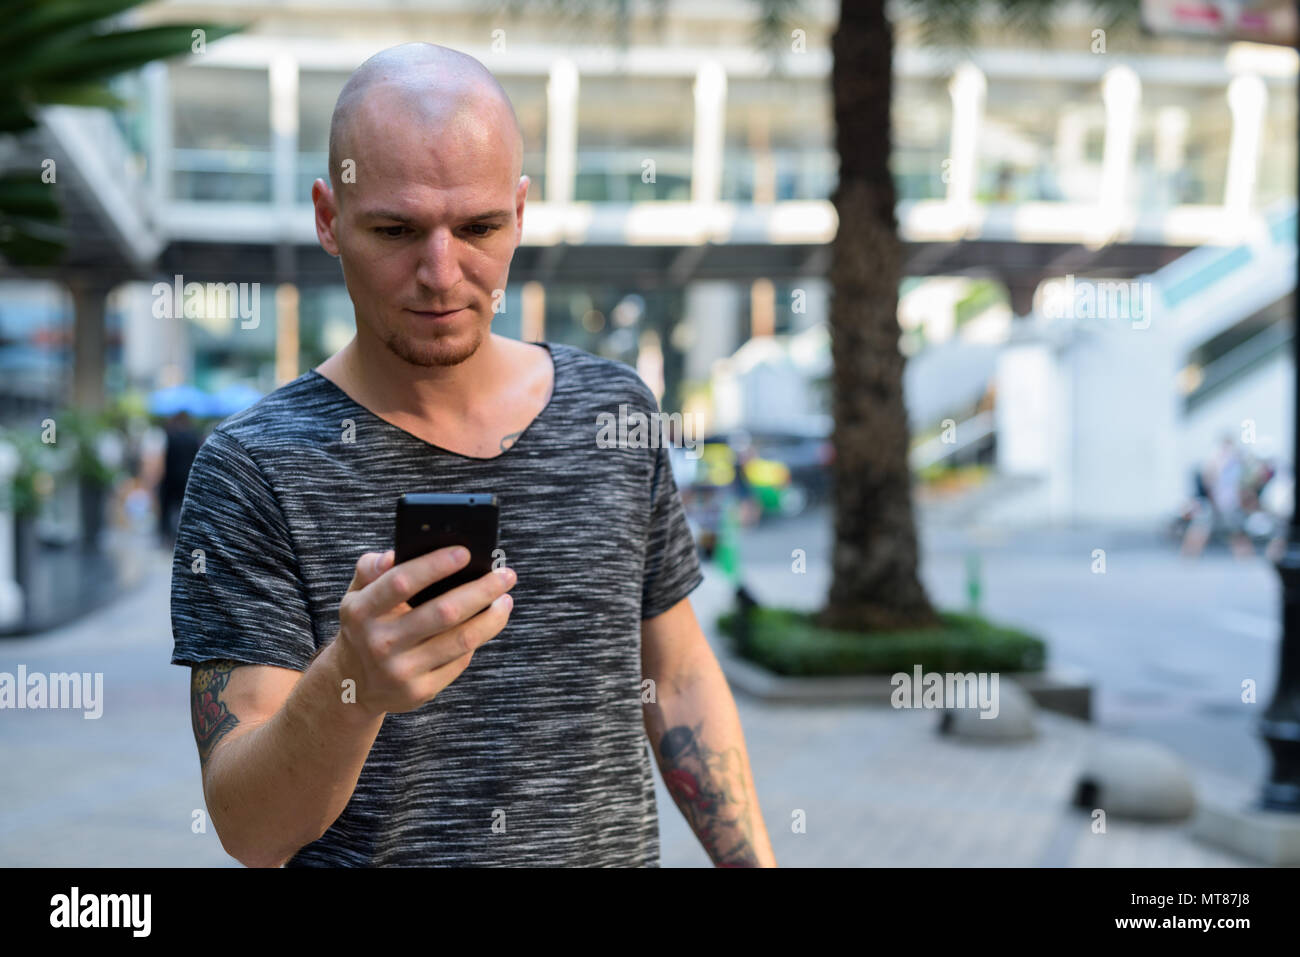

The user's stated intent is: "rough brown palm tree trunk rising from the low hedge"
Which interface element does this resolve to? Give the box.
[819,0,936,631]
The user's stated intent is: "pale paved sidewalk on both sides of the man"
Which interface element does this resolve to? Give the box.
[0,554,1253,867]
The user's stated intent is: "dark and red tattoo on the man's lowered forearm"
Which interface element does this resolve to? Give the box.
[659,724,758,867]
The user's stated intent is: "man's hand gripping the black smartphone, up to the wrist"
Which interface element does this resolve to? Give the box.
[337,546,516,716]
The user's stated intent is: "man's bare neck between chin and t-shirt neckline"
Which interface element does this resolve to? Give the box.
[317,333,506,421]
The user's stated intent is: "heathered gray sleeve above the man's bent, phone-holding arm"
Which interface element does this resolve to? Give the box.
[172,432,316,671]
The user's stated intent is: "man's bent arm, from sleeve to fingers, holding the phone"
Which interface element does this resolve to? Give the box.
[191,547,515,867]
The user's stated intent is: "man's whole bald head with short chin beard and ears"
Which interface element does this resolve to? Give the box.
[312,43,528,367]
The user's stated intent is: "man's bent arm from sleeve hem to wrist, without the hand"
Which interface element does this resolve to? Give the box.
[191,642,384,867]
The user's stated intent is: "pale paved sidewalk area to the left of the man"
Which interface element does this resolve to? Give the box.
[0,549,241,867]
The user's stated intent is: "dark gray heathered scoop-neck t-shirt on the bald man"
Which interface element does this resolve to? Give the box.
[172,343,703,866]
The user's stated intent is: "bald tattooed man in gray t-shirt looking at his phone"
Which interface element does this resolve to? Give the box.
[172,43,776,867]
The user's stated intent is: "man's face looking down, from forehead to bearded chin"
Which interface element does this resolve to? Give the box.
[312,91,529,367]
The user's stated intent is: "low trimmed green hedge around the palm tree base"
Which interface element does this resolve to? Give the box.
[718,607,1047,677]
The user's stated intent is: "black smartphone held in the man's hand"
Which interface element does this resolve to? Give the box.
[393,492,497,607]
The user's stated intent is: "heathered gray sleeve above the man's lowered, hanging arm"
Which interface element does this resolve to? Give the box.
[641,431,705,620]
